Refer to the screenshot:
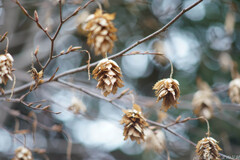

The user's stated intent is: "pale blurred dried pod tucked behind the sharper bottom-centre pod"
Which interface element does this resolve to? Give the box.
[145,128,166,153]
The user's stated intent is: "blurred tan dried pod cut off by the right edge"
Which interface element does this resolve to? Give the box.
[228,78,240,104]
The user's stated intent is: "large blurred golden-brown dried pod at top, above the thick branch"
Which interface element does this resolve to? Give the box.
[84,9,117,57]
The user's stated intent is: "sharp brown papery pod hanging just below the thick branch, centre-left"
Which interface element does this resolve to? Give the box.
[92,58,124,97]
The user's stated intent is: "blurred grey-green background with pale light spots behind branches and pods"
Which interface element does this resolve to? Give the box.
[0,0,240,160]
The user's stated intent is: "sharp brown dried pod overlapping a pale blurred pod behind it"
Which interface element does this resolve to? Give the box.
[120,104,148,144]
